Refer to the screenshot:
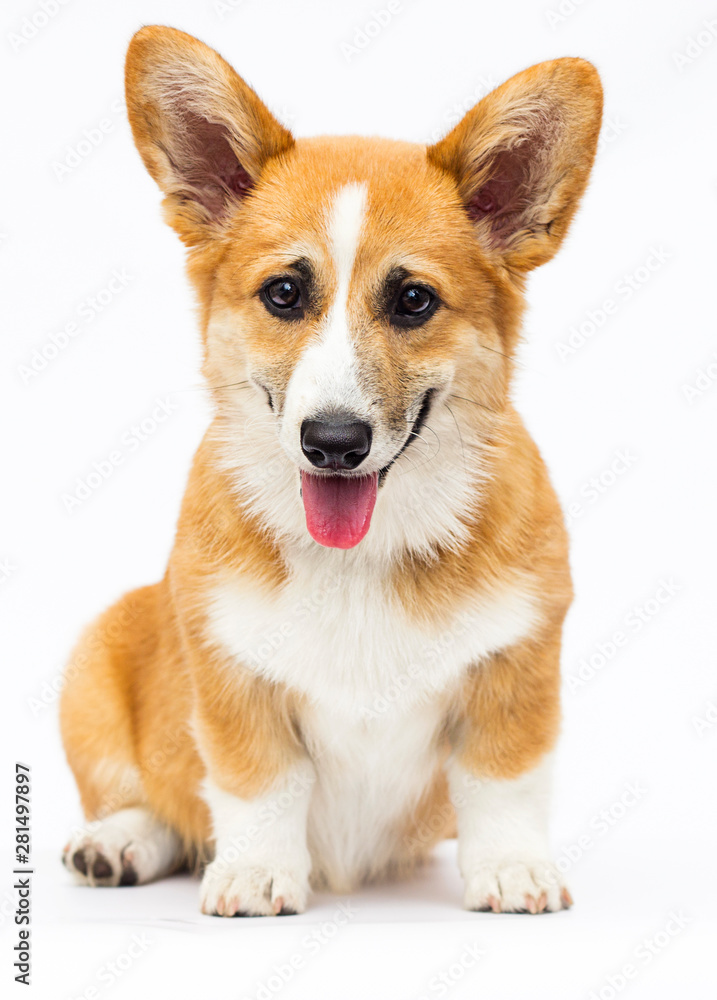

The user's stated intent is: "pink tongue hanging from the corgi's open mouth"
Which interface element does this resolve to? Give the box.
[301,472,378,549]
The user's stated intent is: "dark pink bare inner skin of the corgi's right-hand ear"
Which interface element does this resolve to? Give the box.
[466,136,543,243]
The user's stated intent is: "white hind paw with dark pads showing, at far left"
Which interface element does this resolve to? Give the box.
[62,807,180,886]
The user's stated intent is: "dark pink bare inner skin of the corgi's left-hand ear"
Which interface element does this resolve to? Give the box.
[176,109,254,219]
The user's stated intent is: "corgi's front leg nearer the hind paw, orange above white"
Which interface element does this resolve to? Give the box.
[195,675,315,917]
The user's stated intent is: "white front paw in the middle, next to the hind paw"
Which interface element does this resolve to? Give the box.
[200,861,309,917]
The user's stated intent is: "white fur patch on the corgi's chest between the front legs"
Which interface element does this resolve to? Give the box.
[204,552,538,889]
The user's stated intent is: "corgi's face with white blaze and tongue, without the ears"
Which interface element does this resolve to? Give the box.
[207,140,503,548]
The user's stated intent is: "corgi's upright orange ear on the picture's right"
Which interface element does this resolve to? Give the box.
[428,59,602,272]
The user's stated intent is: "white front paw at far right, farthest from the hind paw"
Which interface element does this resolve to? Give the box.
[465,857,573,913]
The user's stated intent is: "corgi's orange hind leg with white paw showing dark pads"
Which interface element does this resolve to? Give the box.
[60,587,183,886]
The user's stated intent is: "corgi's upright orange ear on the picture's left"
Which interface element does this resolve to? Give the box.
[125,26,294,246]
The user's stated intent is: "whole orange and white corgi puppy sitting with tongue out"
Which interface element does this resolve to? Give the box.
[61,27,602,917]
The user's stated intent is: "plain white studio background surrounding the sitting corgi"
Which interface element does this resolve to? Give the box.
[0,0,717,1000]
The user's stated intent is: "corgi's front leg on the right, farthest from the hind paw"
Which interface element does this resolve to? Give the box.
[449,633,571,913]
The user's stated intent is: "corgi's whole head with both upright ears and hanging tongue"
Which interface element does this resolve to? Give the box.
[127,27,601,550]
